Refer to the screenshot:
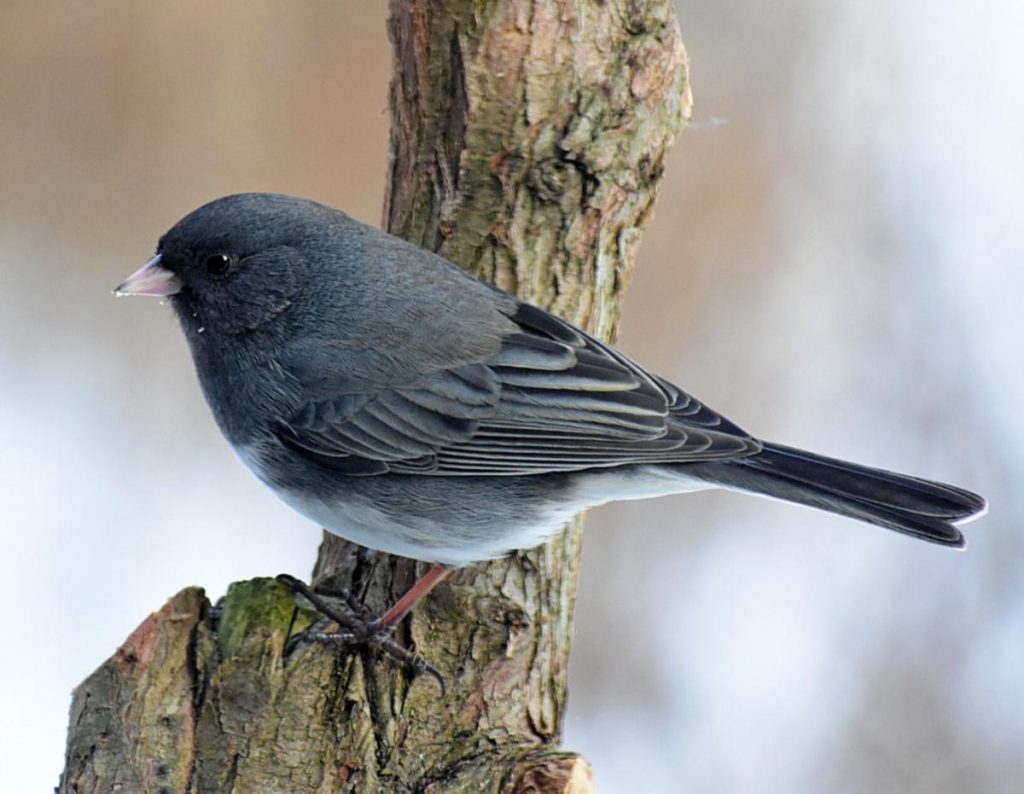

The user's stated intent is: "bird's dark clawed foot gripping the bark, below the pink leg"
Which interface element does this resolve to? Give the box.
[278,574,444,694]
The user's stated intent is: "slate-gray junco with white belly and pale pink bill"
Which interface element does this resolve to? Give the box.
[116,194,985,626]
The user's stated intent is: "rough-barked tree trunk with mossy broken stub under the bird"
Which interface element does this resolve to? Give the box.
[60,0,689,794]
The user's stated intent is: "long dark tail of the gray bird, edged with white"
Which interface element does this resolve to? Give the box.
[697,443,985,548]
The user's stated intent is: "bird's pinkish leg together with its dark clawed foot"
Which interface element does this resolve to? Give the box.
[278,566,452,691]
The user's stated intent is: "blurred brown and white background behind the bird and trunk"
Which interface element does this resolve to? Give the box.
[0,0,1024,794]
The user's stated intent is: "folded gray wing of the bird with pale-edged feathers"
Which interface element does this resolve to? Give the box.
[278,303,761,475]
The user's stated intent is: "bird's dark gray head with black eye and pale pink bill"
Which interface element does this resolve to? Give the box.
[117,193,347,337]
